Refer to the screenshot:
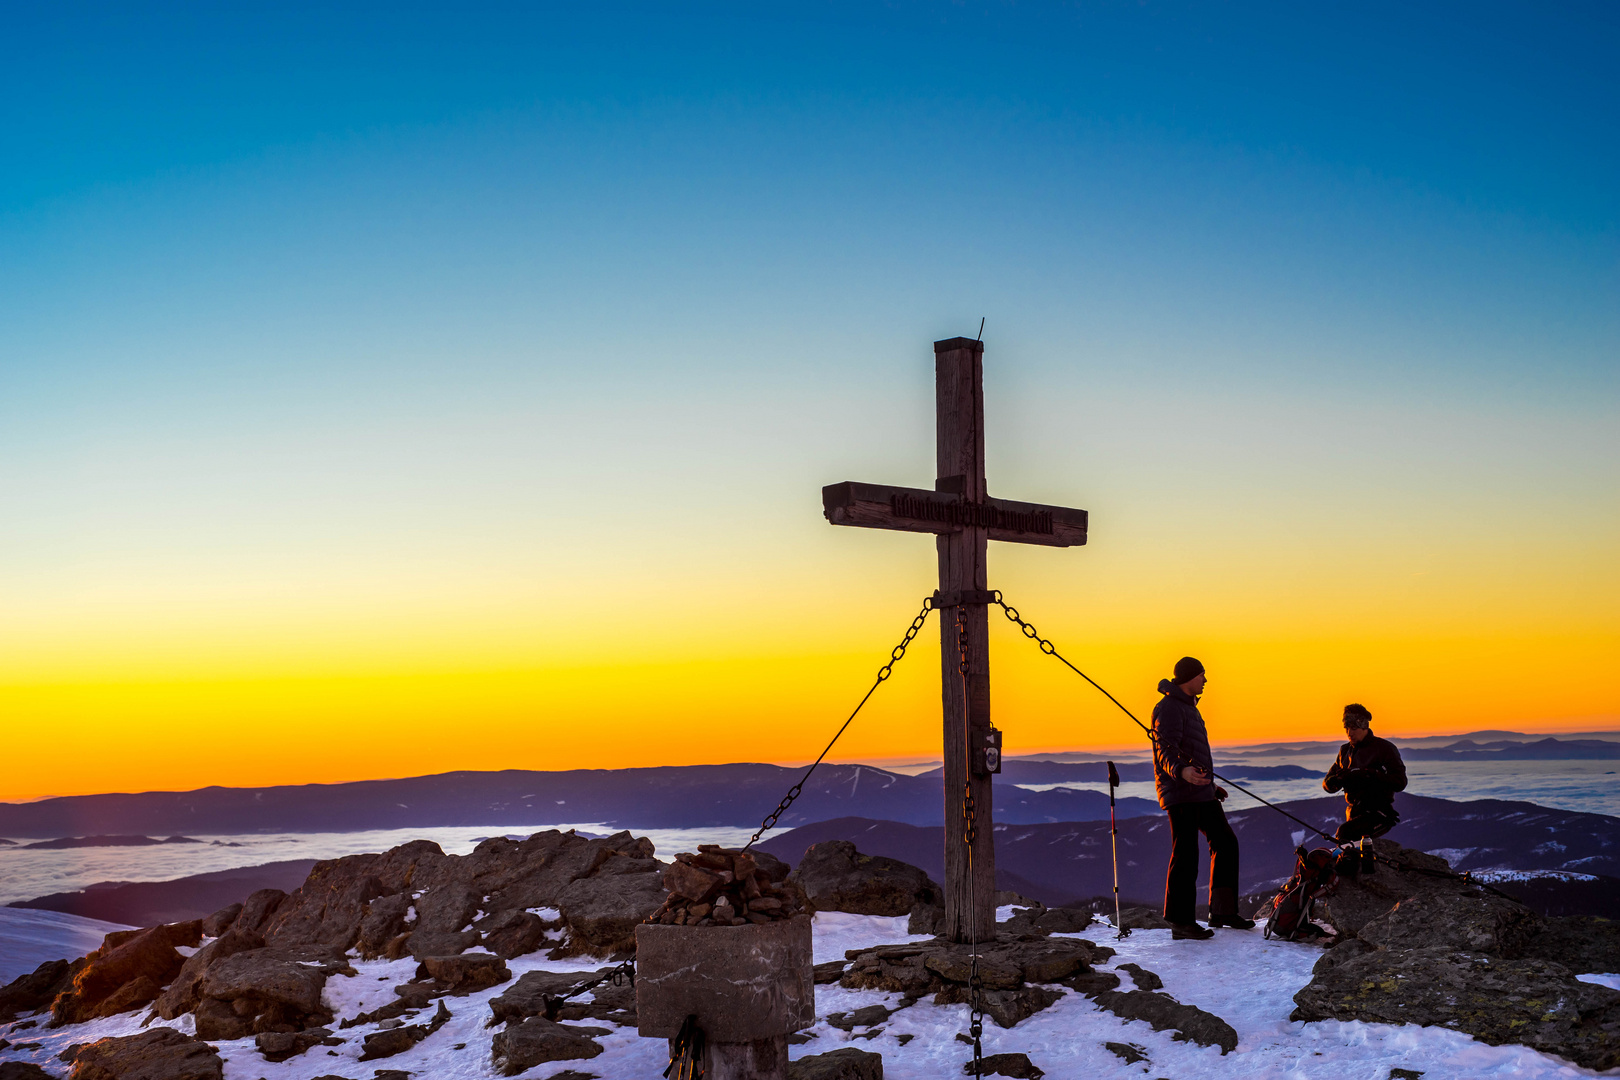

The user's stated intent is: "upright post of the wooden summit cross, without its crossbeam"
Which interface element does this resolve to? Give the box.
[933,337,996,941]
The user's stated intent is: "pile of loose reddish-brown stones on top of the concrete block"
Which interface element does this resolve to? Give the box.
[646,844,805,926]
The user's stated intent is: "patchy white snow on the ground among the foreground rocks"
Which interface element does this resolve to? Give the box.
[0,908,1620,1080]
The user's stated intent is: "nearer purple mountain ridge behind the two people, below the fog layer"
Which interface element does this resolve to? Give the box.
[760,793,1620,905]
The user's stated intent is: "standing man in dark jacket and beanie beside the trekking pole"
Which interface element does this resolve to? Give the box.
[1153,656,1254,939]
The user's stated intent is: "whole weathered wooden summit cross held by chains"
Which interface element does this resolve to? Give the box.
[821,337,1087,941]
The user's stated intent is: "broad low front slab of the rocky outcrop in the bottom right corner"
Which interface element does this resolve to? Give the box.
[1293,945,1620,1070]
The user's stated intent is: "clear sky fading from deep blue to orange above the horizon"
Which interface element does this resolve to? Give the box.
[0,3,1620,798]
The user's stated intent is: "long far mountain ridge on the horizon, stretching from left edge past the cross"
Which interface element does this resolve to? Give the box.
[0,764,1158,837]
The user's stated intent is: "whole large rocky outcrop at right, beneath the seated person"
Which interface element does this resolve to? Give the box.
[1293,840,1620,1070]
